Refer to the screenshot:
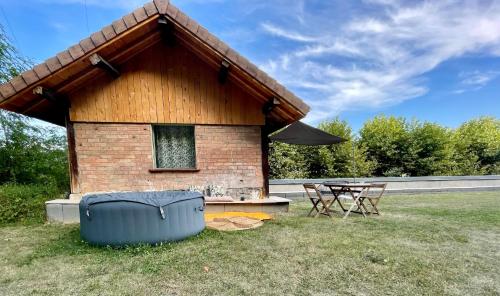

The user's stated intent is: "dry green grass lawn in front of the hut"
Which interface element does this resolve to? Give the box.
[0,191,500,295]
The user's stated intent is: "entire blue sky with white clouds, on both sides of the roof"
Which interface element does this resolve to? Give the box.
[0,0,500,130]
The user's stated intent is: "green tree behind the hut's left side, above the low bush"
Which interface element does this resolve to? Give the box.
[0,26,69,189]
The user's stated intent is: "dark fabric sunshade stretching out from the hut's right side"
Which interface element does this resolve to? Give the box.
[269,121,346,146]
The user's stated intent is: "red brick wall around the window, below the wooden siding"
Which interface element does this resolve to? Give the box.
[72,123,263,197]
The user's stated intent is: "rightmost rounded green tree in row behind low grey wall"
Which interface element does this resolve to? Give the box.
[453,117,500,175]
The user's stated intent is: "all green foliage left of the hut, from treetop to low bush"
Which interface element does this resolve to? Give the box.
[0,22,69,224]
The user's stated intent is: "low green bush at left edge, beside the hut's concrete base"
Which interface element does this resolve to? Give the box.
[0,184,61,225]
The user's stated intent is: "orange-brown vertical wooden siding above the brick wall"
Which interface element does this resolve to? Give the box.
[70,43,264,125]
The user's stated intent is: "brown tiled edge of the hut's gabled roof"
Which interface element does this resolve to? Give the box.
[0,0,309,122]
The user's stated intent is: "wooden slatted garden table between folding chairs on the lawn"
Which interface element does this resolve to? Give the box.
[323,182,386,218]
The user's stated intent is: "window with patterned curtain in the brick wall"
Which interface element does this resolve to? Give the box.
[153,125,196,169]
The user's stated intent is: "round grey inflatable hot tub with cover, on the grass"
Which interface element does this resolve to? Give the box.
[80,191,205,246]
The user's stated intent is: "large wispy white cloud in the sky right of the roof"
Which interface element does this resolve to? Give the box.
[261,0,500,121]
